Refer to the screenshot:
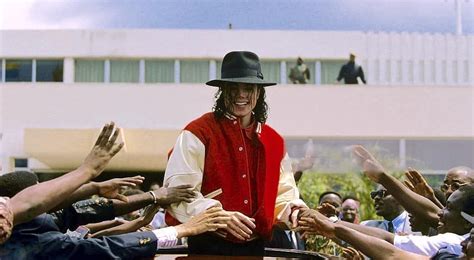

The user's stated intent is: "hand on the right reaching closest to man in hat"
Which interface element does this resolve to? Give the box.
[298,210,336,238]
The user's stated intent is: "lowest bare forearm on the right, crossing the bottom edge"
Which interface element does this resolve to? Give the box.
[334,224,428,259]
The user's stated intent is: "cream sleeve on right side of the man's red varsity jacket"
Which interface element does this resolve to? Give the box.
[275,154,308,227]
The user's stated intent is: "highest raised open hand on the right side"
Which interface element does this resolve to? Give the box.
[352,145,385,183]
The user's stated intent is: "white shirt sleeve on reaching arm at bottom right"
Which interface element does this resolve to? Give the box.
[393,233,464,257]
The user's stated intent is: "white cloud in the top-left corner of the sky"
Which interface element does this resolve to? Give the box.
[0,0,106,29]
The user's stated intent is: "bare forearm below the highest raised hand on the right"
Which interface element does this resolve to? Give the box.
[380,173,440,226]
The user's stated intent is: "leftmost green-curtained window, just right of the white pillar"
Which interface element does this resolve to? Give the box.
[74,60,104,82]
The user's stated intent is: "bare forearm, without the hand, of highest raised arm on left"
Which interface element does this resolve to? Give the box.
[11,168,92,225]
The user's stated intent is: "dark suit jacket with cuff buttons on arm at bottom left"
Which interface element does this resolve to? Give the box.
[0,214,157,260]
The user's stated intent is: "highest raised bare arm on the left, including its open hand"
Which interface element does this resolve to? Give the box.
[11,122,123,225]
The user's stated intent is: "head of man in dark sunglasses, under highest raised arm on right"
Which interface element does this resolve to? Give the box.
[370,185,405,221]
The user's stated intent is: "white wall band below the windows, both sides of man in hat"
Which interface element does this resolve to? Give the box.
[0,83,474,171]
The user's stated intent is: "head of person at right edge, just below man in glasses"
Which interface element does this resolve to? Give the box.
[438,184,474,235]
